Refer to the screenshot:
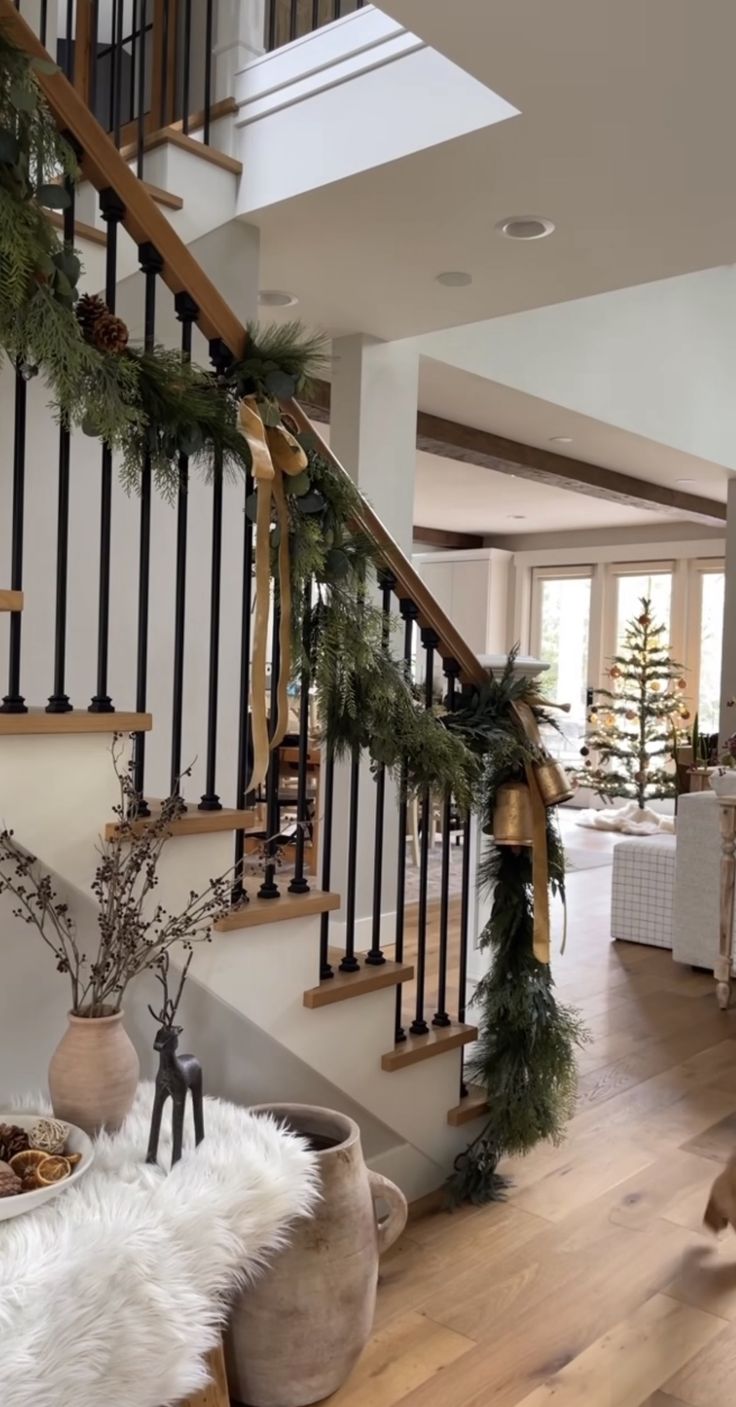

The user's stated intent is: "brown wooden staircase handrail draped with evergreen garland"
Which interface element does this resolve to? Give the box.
[0,0,486,684]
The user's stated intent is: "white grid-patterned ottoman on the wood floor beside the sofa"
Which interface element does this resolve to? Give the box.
[611,836,675,948]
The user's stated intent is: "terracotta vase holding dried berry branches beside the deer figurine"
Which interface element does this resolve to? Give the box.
[0,739,229,1133]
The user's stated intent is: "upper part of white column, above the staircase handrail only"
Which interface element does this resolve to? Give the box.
[329,333,419,557]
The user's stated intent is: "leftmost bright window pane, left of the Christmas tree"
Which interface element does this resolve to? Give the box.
[532,567,591,763]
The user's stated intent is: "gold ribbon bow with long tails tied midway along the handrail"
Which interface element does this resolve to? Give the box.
[238,395,308,794]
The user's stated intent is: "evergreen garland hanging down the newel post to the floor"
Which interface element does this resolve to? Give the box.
[448,651,585,1203]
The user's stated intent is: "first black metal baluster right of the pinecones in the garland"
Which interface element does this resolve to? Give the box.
[132,242,163,816]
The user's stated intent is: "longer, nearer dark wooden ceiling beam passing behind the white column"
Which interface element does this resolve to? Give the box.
[308,381,726,528]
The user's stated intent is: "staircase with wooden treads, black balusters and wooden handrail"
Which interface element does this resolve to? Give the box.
[0,0,486,1197]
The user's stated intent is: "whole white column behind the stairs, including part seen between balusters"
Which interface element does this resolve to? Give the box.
[323,335,418,957]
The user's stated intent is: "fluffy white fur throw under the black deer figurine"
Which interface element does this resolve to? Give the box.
[0,1085,318,1407]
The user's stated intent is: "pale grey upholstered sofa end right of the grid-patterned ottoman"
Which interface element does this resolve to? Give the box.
[673,792,736,971]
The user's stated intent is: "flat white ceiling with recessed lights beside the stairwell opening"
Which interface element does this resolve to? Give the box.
[249,0,736,339]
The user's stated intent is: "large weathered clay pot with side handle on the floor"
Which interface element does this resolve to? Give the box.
[225,1104,407,1407]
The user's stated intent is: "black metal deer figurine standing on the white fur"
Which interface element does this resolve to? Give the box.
[146,953,204,1168]
